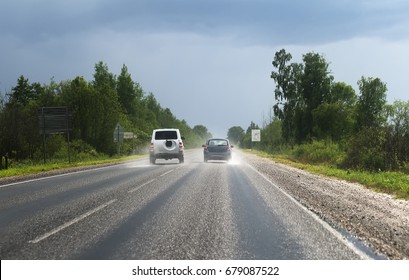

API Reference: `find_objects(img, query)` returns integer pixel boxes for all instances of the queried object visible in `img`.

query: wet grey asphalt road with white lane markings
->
[0,150,369,260]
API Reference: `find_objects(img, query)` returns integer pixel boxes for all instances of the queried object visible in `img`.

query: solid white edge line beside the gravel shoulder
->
[247,164,373,260]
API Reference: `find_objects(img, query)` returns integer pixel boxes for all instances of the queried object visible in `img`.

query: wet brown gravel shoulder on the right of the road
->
[243,153,409,259]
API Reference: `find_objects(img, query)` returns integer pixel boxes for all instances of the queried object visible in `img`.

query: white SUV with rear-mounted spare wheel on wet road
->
[149,128,185,164]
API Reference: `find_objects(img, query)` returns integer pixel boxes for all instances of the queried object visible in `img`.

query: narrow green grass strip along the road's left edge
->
[0,155,143,178]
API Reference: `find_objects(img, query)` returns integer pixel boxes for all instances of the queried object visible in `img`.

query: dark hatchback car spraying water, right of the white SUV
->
[202,138,233,162]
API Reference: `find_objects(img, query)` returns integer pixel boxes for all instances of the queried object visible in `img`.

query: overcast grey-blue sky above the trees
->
[0,0,409,137]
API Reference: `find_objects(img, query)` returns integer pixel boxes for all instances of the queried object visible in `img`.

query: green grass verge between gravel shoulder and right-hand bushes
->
[245,150,409,200]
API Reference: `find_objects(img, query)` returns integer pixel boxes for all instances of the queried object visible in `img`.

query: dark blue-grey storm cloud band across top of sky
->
[0,0,409,44]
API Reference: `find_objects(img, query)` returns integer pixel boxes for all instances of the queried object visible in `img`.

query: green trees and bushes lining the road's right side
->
[228,49,409,172]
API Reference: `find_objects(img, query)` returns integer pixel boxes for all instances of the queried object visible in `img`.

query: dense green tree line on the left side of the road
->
[0,61,210,161]
